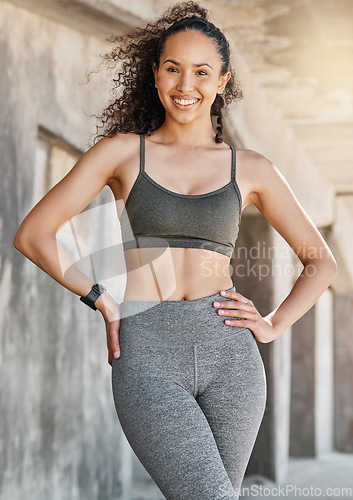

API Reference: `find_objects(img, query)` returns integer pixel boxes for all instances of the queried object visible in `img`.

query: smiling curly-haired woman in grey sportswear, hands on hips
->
[14,2,336,500]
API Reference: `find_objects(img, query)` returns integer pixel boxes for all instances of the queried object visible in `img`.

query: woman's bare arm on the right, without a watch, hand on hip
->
[213,153,337,343]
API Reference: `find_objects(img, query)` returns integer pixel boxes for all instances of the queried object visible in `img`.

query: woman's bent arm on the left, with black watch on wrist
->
[13,134,124,364]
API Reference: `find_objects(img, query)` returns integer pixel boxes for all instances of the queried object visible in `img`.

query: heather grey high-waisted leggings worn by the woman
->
[112,286,267,500]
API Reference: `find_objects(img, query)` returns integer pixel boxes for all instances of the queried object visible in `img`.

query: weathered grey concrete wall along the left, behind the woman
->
[0,2,126,500]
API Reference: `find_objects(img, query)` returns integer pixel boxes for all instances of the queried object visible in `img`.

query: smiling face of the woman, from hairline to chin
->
[153,30,231,123]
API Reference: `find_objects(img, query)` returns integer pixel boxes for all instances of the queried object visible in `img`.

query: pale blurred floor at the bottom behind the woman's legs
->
[131,452,353,500]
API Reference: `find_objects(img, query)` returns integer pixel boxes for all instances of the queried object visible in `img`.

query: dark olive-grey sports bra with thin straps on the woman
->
[120,134,242,257]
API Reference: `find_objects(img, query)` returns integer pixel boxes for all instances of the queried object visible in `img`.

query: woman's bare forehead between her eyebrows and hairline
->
[163,29,219,60]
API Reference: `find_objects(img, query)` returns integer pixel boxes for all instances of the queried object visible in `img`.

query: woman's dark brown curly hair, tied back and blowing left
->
[94,1,243,142]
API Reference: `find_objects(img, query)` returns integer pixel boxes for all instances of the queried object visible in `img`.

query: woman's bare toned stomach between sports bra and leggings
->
[123,247,233,301]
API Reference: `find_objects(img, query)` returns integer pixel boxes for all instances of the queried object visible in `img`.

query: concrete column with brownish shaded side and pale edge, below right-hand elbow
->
[290,289,333,457]
